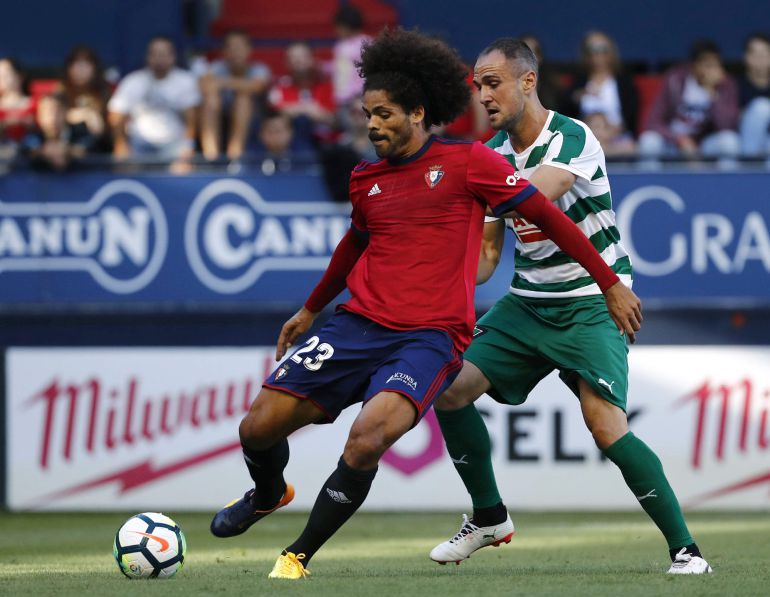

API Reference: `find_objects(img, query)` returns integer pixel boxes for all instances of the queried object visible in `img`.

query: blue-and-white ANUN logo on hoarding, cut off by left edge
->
[0,179,168,294]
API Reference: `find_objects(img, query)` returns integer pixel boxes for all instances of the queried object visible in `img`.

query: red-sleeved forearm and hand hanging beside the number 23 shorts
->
[275,228,369,361]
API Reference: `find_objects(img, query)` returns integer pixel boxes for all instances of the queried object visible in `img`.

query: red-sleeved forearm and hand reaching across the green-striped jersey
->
[504,191,642,343]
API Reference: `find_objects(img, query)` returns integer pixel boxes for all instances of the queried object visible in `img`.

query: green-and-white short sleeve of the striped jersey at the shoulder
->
[541,122,604,181]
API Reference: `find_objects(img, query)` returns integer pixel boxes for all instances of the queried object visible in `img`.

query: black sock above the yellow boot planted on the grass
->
[286,458,377,564]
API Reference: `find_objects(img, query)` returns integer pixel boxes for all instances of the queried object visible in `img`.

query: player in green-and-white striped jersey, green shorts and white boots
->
[430,38,711,574]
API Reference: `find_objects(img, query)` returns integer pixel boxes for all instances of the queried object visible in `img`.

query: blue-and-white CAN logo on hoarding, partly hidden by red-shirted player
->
[184,178,349,294]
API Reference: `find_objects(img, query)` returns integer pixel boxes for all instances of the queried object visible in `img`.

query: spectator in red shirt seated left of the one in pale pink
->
[268,42,335,149]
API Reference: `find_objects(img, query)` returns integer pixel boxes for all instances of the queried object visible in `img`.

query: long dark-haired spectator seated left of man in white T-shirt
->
[55,46,110,151]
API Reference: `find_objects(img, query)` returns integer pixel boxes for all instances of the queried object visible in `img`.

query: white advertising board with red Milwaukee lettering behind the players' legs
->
[6,346,770,510]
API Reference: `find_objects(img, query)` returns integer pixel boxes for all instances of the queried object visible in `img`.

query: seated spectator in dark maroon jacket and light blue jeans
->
[639,40,740,160]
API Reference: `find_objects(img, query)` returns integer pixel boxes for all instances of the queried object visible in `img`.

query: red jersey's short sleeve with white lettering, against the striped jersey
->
[467,143,537,216]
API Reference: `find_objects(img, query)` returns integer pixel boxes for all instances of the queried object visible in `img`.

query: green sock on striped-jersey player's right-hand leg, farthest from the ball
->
[604,431,694,549]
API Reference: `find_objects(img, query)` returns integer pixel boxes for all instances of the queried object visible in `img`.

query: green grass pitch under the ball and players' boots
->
[0,512,770,597]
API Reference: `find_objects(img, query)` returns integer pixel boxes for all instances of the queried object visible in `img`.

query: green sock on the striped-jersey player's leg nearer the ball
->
[436,404,502,508]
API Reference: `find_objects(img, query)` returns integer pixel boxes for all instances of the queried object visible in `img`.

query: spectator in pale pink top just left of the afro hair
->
[332,4,371,120]
